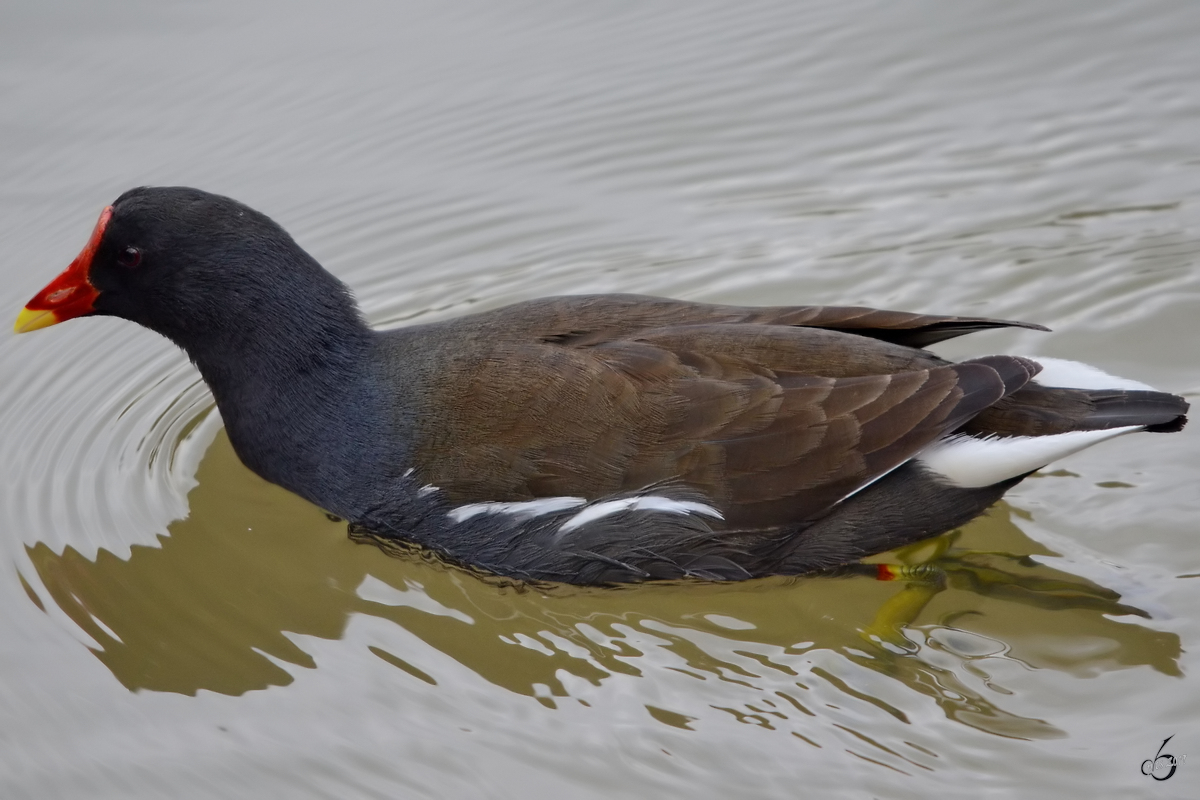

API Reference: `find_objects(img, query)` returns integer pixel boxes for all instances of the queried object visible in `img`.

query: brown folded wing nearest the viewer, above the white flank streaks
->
[418,323,1027,529]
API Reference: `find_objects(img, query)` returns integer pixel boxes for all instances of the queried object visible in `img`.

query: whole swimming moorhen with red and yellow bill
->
[16,187,1188,584]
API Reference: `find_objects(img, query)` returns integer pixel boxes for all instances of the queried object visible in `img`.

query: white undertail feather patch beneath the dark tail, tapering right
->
[917,425,1142,489]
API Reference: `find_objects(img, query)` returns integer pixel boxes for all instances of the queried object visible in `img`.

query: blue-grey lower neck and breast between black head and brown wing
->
[175,273,409,519]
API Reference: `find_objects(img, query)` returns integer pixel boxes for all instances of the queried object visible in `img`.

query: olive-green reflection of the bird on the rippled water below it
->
[29,434,1180,738]
